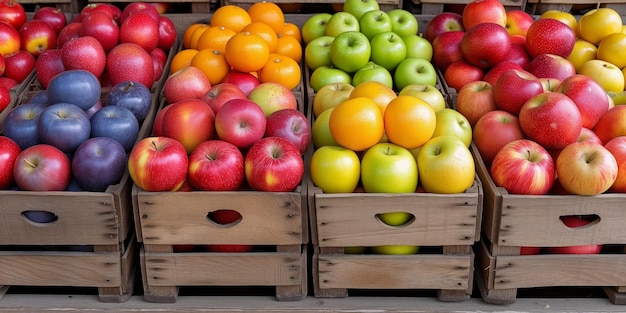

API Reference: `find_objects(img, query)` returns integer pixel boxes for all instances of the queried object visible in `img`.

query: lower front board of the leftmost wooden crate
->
[0,251,122,287]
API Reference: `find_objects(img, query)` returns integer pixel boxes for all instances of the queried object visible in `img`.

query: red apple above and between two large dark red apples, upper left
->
[79,12,120,52]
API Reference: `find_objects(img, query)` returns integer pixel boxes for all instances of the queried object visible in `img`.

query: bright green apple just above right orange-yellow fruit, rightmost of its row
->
[393,58,437,90]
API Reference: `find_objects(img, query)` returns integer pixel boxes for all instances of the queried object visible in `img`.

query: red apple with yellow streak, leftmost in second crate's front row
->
[128,137,189,191]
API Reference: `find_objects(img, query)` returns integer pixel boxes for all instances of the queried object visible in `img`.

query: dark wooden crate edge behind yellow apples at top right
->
[526,0,626,15]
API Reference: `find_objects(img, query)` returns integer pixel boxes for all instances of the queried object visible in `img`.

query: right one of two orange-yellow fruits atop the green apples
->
[383,96,437,149]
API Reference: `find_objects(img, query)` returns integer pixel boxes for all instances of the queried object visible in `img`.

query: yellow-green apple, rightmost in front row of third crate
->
[417,135,476,194]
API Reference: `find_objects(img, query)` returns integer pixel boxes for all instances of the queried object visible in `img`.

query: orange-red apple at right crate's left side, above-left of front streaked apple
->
[472,110,525,166]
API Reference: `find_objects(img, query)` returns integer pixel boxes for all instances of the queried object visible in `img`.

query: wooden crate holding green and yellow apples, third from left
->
[309,169,482,301]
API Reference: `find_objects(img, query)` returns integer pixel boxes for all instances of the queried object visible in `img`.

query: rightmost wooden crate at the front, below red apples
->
[473,143,626,304]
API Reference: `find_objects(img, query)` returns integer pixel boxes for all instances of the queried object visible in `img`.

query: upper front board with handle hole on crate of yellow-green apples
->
[314,188,480,247]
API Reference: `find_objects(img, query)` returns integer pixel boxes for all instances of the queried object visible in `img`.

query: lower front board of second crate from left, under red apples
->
[142,252,306,287]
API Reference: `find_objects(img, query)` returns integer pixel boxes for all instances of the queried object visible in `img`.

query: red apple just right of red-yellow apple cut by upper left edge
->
[19,20,57,57]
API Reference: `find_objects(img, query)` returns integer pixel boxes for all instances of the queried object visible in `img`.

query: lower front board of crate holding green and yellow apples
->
[315,254,474,290]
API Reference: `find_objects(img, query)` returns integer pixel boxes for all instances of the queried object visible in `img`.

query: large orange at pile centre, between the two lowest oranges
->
[224,32,270,72]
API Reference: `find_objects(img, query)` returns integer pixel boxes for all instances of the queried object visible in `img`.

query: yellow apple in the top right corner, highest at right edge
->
[578,8,623,45]
